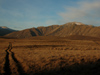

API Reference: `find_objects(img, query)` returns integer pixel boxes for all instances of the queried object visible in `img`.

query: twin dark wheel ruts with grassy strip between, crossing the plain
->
[4,43,25,75]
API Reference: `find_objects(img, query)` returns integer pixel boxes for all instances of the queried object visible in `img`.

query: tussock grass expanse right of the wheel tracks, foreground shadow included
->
[12,40,100,75]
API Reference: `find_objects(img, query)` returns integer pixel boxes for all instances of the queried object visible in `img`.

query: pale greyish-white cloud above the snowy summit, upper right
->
[58,0,100,25]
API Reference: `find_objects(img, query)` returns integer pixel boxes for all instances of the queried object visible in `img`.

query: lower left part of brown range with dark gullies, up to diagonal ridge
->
[5,25,58,38]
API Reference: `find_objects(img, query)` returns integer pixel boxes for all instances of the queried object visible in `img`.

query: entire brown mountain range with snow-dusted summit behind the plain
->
[5,22,100,38]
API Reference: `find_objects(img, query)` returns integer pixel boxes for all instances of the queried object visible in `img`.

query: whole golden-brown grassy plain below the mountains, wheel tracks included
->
[0,36,100,75]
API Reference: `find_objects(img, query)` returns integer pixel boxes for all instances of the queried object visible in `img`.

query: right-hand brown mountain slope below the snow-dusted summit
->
[48,24,100,37]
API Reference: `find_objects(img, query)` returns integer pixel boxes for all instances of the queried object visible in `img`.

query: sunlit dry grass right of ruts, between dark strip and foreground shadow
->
[13,49,100,74]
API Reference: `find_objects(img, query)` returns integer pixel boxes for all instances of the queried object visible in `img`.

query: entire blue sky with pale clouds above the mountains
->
[0,0,100,30]
